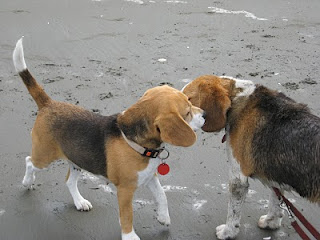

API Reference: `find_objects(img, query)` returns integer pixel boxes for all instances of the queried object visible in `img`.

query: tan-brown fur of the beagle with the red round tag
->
[20,68,199,233]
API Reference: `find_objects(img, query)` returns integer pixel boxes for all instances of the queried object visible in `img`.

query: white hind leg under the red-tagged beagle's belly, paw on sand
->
[66,162,92,211]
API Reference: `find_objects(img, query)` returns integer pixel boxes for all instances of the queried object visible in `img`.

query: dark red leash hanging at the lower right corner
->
[273,187,320,240]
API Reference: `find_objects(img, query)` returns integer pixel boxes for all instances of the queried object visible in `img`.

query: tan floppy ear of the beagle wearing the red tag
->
[155,113,197,147]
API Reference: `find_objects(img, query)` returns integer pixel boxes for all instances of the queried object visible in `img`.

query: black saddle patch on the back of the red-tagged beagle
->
[52,111,121,176]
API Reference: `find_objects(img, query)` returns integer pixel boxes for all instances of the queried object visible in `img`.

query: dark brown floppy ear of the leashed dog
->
[199,83,231,132]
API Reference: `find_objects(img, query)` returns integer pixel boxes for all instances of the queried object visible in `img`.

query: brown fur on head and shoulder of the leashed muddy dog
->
[183,75,320,201]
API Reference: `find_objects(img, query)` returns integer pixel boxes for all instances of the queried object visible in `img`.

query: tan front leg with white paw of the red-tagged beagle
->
[117,186,140,240]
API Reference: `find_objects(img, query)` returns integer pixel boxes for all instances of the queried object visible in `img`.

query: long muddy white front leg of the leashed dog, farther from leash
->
[216,145,249,239]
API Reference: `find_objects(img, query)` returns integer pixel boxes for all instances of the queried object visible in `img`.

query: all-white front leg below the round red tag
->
[148,175,170,226]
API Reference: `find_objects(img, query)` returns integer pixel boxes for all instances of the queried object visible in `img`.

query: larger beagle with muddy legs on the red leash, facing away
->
[182,75,320,239]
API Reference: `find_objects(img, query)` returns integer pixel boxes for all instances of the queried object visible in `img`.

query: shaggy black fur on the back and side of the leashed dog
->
[250,86,320,198]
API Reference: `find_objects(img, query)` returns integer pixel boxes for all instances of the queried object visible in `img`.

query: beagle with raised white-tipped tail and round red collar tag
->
[13,39,205,240]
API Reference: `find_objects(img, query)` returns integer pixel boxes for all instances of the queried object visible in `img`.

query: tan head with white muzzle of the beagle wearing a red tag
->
[118,85,205,147]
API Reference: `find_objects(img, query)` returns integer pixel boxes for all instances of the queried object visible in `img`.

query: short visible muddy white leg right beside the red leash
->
[258,189,284,229]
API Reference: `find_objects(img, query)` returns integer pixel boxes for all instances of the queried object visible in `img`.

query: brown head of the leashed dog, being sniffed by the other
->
[182,75,232,132]
